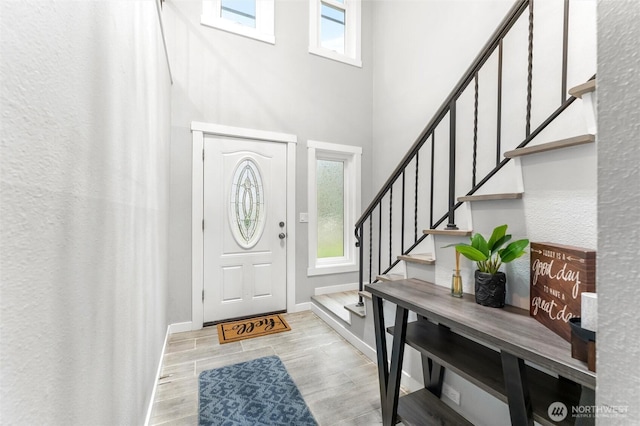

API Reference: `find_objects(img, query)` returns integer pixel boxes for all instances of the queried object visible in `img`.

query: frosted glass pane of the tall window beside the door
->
[316,160,344,259]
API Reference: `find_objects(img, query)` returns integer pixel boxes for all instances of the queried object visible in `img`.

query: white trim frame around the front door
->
[191,121,298,330]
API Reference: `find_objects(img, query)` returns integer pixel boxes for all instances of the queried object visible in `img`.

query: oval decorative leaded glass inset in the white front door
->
[229,158,265,248]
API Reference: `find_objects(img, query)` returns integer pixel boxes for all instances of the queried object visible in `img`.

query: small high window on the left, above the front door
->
[200,0,276,44]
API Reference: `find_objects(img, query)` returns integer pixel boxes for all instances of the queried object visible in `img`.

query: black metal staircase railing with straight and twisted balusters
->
[355,0,592,303]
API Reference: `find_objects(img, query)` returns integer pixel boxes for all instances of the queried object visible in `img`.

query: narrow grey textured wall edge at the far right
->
[596,0,640,425]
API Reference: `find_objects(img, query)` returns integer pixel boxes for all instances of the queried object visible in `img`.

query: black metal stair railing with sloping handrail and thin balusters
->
[355,0,595,304]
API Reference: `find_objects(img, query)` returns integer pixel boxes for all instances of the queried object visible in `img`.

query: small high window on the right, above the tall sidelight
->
[309,0,362,67]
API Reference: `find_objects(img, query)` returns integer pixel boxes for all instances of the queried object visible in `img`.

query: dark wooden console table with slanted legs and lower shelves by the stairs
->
[366,279,596,426]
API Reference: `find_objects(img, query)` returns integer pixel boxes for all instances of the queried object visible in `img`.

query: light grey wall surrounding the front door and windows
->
[165,0,372,322]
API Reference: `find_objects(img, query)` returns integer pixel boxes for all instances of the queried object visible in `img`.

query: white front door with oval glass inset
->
[203,136,287,323]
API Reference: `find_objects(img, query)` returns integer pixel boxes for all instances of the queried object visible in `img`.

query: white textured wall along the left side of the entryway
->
[0,1,170,425]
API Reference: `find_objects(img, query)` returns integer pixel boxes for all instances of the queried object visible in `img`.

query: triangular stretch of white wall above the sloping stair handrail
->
[373,0,513,188]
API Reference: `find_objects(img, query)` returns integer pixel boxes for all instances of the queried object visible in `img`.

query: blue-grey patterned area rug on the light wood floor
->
[198,356,317,426]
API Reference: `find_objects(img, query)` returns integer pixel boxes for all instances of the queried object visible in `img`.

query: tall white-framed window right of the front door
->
[307,141,362,275]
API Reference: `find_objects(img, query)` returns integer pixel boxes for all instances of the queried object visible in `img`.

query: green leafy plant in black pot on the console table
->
[453,225,529,308]
